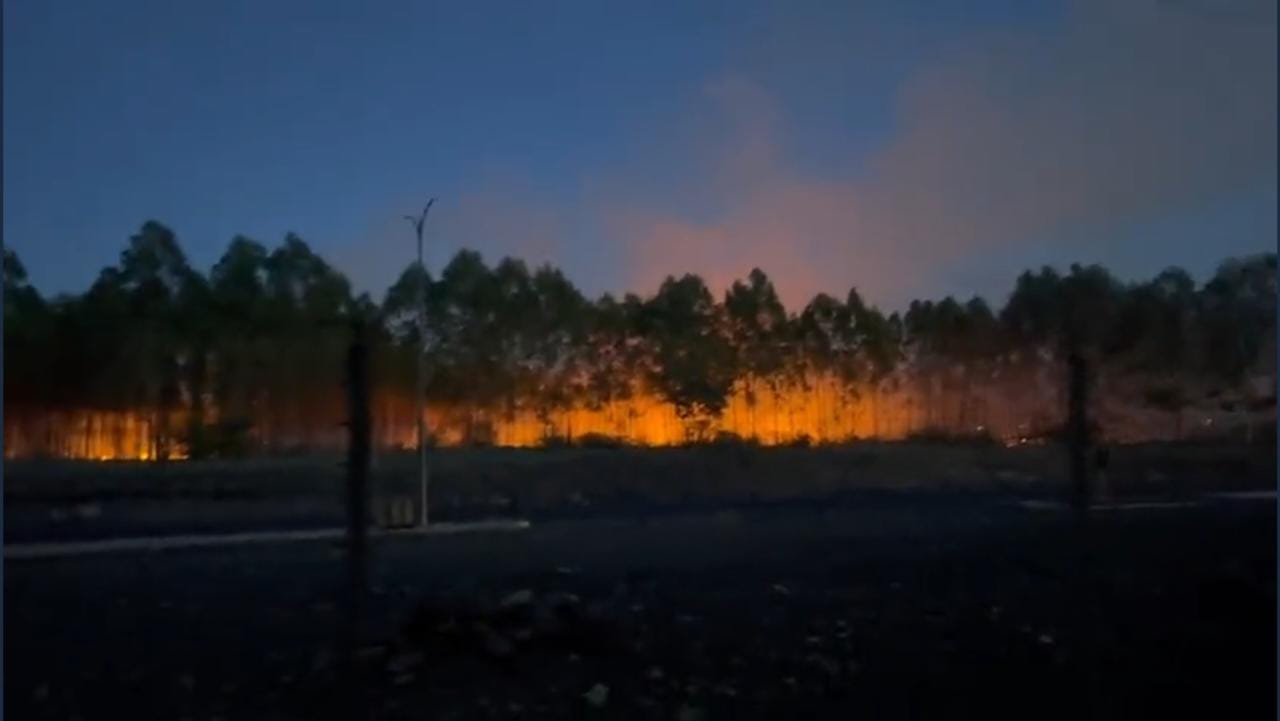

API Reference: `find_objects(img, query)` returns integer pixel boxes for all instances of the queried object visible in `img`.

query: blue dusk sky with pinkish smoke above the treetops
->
[4,0,1276,309]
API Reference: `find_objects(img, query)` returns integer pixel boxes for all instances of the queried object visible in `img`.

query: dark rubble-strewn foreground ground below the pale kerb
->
[4,490,1276,721]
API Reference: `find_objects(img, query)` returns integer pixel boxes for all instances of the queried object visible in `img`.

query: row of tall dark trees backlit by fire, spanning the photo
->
[4,222,1276,458]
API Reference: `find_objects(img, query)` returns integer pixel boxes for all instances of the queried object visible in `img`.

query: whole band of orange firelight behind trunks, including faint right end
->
[4,371,1275,461]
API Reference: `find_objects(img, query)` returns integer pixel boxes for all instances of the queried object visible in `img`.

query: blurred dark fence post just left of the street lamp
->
[343,320,371,703]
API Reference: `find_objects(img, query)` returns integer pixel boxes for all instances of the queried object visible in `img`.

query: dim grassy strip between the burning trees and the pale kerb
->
[4,443,1276,543]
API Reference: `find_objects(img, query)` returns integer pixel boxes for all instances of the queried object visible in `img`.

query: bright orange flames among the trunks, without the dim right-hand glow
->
[5,371,977,461]
